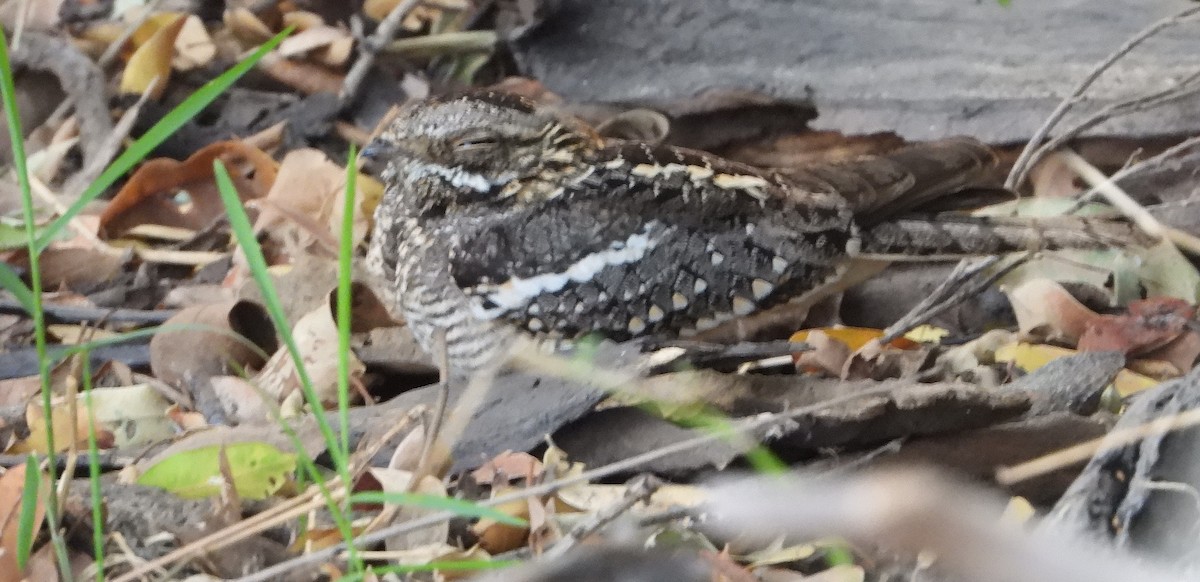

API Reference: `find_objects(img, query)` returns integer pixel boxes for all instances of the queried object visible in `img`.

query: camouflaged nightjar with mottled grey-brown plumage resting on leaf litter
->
[362,92,1137,374]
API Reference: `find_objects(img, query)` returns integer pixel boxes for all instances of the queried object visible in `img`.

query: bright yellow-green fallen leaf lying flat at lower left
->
[138,443,296,499]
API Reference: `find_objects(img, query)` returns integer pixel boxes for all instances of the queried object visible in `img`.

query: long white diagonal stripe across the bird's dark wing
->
[472,221,660,319]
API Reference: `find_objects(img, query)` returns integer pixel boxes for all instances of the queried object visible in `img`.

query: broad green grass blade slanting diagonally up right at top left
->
[37,26,293,252]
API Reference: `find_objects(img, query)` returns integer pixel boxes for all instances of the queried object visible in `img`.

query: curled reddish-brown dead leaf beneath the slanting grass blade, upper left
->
[100,140,276,236]
